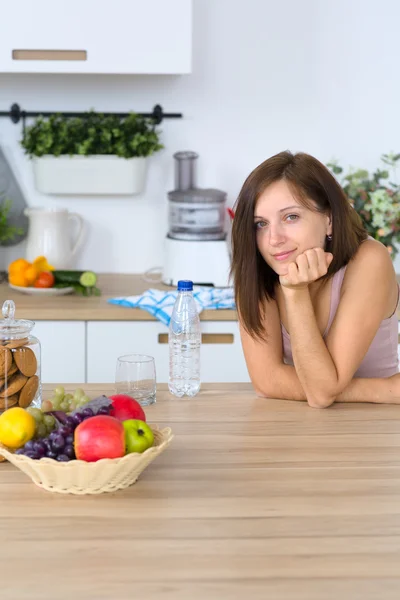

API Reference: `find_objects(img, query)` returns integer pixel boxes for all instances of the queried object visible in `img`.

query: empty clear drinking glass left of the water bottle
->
[115,354,156,406]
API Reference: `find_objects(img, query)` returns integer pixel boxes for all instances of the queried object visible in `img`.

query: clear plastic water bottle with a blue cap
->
[168,280,201,397]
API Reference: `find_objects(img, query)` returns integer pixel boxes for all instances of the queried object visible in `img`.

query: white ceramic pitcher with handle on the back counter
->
[24,208,84,269]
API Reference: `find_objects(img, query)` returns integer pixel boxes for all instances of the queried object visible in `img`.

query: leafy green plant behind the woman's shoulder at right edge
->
[327,153,400,259]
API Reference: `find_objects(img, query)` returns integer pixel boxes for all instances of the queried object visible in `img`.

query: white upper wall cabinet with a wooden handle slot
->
[0,0,192,74]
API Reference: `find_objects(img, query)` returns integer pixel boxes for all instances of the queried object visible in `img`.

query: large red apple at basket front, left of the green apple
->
[74,415,125,462]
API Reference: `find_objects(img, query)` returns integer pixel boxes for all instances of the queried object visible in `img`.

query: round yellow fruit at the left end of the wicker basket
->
[0,406,35,450]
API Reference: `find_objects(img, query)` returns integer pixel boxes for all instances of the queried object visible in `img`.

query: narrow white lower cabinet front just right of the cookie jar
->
[32,321,86,384]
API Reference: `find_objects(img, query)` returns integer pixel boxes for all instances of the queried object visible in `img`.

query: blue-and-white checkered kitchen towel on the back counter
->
[108,286,235,325]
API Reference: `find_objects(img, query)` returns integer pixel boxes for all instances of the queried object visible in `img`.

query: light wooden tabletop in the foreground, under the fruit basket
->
[0,384,400,600]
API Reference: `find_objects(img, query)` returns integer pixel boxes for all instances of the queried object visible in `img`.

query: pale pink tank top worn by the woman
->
[281,265,400,377]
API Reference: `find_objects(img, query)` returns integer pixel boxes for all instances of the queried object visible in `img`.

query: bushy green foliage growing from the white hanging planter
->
[21,111,163,158]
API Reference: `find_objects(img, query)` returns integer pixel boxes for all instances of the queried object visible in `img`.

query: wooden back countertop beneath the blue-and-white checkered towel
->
[0,273,237,321]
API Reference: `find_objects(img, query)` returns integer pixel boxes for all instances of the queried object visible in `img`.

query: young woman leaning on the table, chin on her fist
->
[232,152,400,408]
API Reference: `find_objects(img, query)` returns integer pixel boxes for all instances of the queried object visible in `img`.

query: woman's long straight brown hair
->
[231,151,368,339]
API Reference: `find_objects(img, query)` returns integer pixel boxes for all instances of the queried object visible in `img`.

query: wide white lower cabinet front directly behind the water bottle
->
[87,321,250,383]
